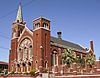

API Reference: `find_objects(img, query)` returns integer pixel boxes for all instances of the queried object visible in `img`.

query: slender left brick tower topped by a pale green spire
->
[9,5,25,72]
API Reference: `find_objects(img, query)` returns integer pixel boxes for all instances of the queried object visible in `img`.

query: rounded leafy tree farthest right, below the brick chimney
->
[86,53,96,66]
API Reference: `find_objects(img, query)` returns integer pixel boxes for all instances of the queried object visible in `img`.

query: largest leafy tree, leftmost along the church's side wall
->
[62,49,74,65]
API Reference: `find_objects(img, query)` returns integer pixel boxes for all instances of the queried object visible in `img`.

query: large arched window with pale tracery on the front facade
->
[18,38,33,61]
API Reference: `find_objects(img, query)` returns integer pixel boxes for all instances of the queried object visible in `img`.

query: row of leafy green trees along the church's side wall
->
[62,49,96,67]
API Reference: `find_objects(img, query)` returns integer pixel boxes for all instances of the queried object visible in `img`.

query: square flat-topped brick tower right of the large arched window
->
[33,17,51,69]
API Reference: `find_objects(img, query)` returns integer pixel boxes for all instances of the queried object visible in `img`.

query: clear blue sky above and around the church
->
[0,0,100,62]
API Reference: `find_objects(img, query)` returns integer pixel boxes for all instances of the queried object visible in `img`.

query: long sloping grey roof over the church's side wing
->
[51,36,84,51]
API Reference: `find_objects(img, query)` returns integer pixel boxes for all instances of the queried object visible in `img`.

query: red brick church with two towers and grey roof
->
[9,6,94,72]
